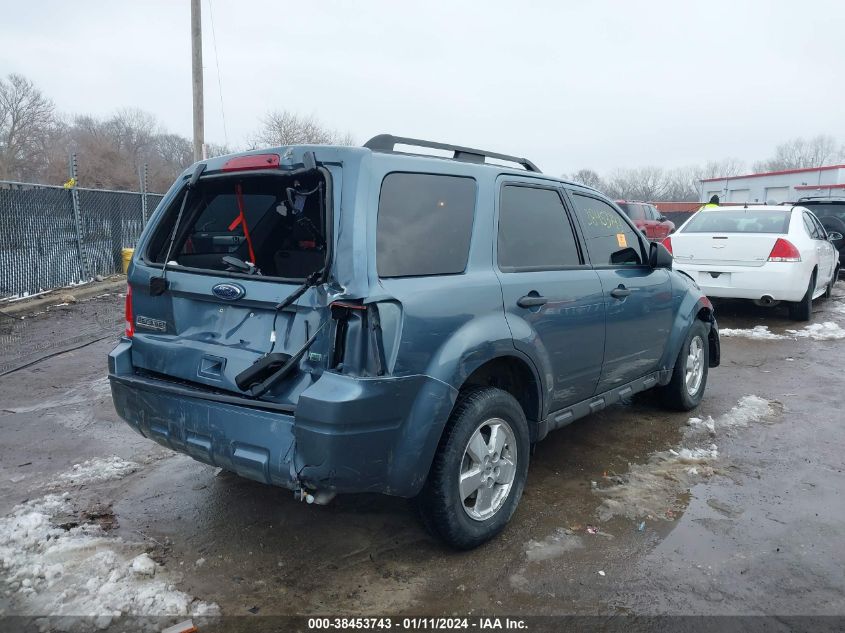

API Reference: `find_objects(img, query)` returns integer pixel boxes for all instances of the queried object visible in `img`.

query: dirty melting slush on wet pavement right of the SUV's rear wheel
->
[595,395,781,521]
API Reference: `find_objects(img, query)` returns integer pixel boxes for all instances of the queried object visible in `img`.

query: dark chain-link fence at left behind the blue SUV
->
[0,181,162,299]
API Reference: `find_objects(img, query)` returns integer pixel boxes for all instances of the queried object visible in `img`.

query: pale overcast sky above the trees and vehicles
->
[0,0,845,175]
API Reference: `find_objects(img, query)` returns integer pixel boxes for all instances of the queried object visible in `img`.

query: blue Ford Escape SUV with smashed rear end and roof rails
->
[109,135,719,549]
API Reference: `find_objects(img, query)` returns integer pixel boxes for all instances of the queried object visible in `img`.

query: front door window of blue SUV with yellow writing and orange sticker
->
[572,193,643,266]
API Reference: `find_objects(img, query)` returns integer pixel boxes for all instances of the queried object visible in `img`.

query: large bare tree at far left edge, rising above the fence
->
[0,74,56,180]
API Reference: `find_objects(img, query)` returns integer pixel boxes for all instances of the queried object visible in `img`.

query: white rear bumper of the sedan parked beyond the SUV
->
[673,259,810,301]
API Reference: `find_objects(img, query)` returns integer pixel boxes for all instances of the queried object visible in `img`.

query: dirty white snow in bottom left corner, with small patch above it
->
[0,457,220,631]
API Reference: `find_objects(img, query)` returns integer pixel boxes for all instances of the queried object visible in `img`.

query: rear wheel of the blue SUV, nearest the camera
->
[414,387,530,550]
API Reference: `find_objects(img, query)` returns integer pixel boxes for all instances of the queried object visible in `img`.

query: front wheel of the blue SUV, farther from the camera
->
[660,319,710,411]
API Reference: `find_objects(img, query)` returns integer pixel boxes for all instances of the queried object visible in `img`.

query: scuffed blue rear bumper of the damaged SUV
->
[109,340,457,497]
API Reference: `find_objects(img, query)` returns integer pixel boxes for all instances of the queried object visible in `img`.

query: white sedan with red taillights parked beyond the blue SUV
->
[663,205,842,321]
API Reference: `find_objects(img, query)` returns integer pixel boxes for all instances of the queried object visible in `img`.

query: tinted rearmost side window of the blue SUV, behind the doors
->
[376,173,476,277]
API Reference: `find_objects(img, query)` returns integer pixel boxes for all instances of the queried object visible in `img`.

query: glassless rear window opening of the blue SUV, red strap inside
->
[147,175,329,279]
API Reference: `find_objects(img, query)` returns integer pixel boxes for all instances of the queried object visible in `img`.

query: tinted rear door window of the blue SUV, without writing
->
[498,185,581,272]
